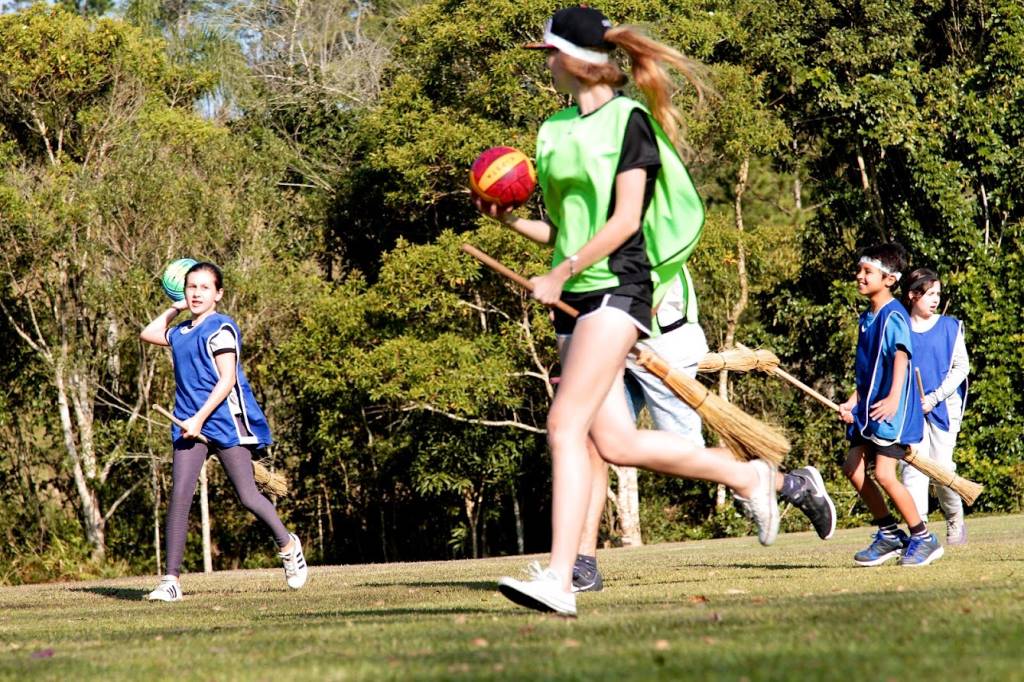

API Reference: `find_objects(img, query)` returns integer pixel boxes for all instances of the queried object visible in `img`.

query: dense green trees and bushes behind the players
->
[0,0,1024,582]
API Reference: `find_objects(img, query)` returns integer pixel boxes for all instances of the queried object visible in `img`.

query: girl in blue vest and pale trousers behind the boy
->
[903,267,971,545]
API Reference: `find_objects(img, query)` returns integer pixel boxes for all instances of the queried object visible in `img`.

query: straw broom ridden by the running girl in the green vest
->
[462,244,790,465]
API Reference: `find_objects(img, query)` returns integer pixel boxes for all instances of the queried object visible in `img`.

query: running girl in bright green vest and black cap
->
[477,7,778,615]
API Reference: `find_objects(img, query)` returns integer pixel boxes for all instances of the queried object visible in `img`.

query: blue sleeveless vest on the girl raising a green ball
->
[167,312,272,447]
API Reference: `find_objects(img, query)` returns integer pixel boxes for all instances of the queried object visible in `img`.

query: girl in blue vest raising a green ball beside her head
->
[139,262,307,601]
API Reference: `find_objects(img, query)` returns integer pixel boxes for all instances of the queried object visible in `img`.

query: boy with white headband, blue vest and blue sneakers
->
[840,244,943,566]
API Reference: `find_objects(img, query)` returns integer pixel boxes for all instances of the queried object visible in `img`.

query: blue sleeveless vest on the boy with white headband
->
[847,299,925,445]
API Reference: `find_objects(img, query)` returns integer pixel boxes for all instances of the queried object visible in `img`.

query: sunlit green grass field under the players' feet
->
[0,516,1024,682]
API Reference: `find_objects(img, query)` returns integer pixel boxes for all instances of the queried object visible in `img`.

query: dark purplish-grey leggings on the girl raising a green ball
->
[164,440,291,576]
